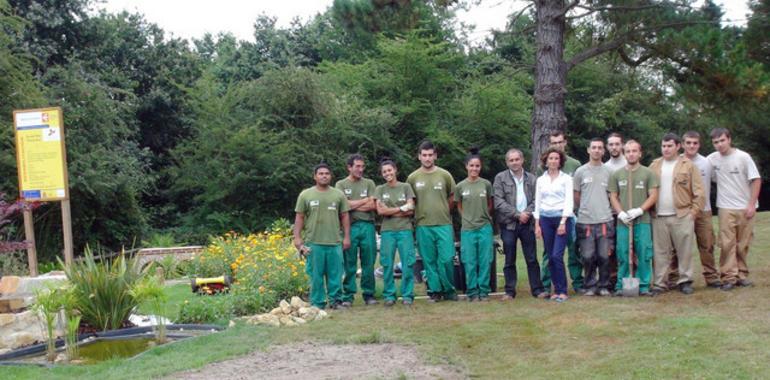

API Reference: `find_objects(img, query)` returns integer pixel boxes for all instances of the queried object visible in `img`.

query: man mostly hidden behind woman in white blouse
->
[537,131,585,294]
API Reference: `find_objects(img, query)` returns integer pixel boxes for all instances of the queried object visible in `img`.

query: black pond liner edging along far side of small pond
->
[0,324,223,365]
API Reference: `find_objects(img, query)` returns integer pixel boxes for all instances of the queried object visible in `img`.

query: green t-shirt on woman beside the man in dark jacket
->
[455,178,493,230]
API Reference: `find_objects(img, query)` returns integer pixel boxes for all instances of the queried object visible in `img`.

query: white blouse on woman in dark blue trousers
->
[533,171,574,219]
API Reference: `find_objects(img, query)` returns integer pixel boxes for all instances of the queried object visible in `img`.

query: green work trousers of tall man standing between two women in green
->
[416,224,457,298]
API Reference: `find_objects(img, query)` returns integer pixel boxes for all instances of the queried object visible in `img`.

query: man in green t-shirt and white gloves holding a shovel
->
[608,140,659,296]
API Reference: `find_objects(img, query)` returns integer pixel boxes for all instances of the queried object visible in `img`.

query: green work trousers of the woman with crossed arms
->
[380,230,415,301]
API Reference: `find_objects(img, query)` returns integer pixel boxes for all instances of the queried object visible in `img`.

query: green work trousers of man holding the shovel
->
[615,222,653,292]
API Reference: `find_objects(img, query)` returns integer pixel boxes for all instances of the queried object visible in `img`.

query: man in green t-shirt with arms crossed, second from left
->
[334,153,377,306]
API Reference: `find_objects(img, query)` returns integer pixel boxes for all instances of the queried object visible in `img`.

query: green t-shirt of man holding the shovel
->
[608,165,660,223]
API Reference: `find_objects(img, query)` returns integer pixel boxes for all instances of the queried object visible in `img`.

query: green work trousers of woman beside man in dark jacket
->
[460,224,494,298]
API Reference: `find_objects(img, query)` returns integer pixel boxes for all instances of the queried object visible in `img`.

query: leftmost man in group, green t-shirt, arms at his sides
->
[294,163,350,309]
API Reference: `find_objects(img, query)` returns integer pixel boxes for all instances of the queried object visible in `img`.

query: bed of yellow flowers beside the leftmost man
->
[178,227,309,323]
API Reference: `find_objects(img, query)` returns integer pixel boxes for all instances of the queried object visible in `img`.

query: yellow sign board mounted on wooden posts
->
[13,107,69,201]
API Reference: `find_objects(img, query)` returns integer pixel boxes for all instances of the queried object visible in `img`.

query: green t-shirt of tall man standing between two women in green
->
[406,167,455,226]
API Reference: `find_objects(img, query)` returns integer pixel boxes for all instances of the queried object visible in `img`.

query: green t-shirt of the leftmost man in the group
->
[294,186,349,245]
